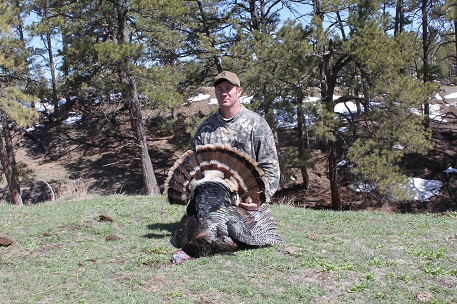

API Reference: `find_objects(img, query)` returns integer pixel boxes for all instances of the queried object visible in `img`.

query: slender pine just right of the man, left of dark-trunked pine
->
[268,22,318,190]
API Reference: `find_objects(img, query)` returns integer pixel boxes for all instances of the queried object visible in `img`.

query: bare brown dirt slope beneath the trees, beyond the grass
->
[0,86,457,213]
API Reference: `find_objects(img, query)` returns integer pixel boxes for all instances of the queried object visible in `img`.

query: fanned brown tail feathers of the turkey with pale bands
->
[164,145,268,205]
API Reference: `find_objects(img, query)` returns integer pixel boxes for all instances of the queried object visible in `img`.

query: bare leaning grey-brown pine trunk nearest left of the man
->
[129,76,160,195]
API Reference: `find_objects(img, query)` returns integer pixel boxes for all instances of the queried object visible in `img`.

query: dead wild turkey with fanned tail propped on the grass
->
[164,145,282,260]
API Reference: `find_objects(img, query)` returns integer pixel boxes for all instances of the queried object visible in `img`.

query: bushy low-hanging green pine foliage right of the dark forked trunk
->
[348,20,436,200]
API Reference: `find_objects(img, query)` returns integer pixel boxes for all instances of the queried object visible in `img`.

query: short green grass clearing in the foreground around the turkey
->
[0,196,457,304]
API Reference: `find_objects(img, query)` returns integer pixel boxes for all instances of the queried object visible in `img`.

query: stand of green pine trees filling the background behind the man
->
[0,0,457,210]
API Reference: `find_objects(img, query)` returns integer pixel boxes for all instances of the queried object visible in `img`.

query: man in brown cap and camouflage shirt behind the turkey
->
[194,71,280,210]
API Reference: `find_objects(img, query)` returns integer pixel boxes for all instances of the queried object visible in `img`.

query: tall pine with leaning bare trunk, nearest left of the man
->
[43,0,191,194]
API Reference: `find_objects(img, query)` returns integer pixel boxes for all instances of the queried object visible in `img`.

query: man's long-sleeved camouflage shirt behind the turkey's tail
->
[194,105,280,197]
